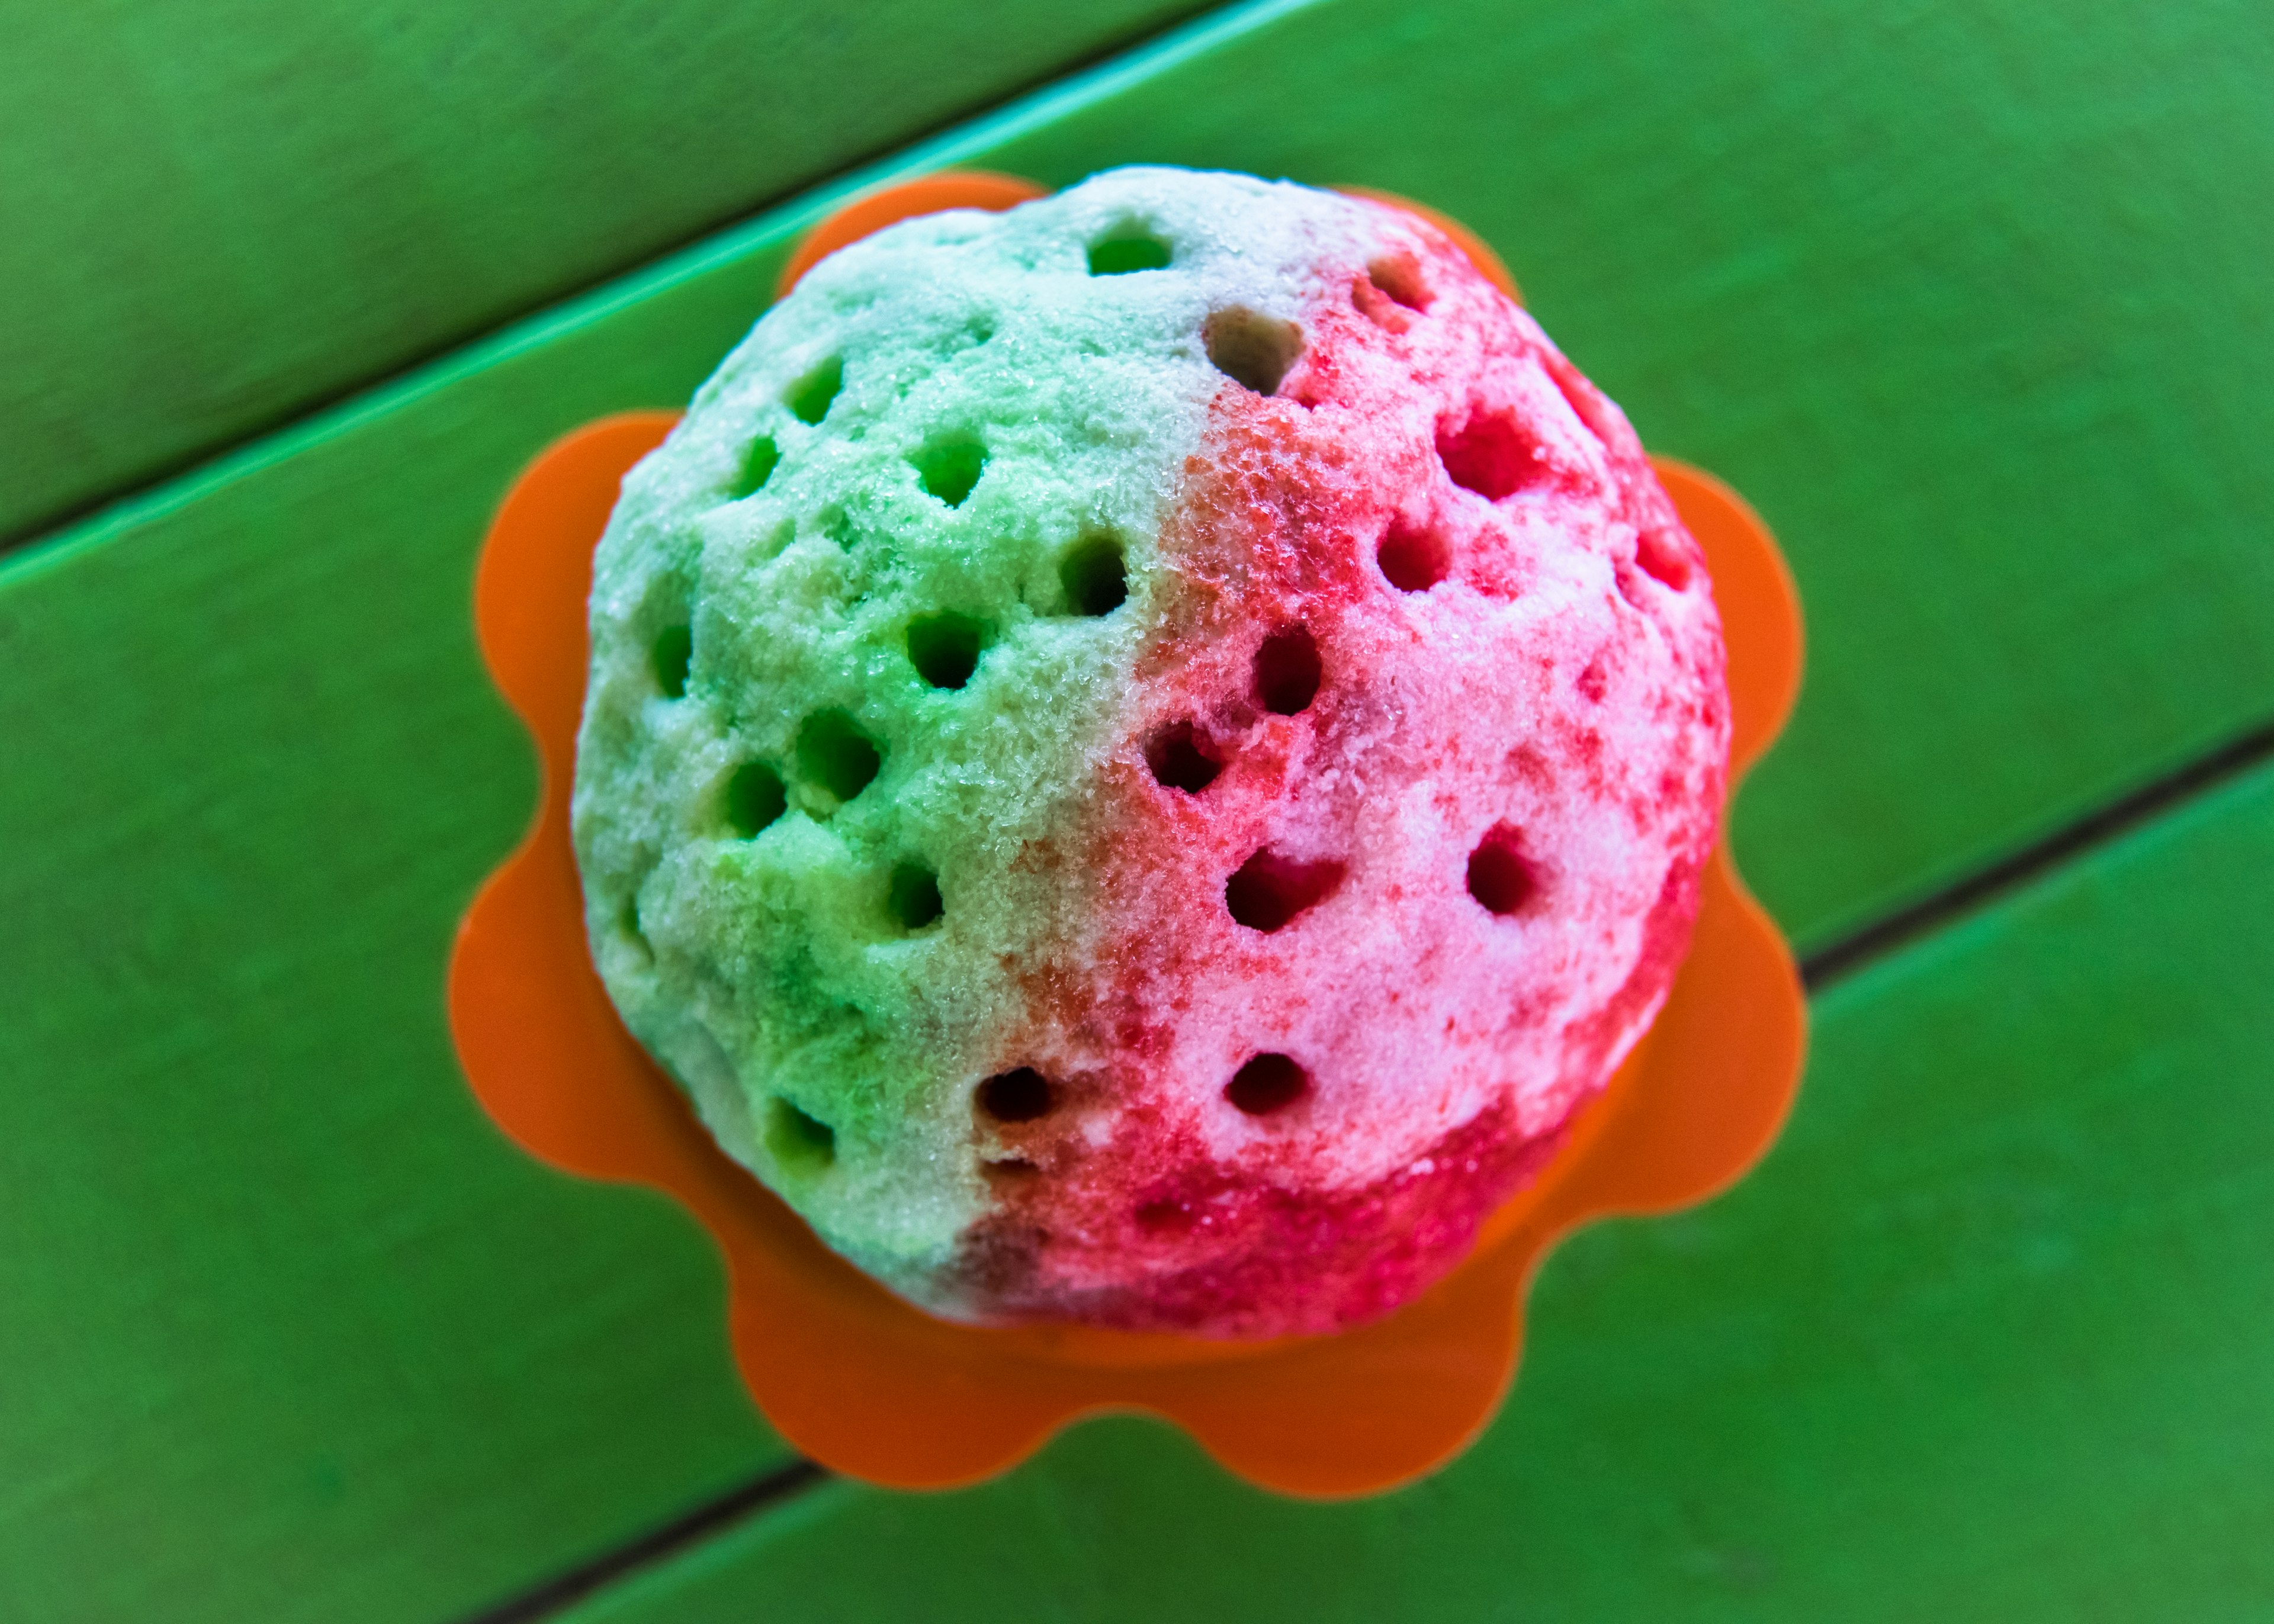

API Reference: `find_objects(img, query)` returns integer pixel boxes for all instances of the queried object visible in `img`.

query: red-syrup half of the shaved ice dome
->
[958,193,1728,1337]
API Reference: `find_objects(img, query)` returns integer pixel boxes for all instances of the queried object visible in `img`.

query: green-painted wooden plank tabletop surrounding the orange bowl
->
[0,0,2274,1624]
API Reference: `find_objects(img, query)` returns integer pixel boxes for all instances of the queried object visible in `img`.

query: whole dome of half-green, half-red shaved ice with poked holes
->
[573,168,1728,1335]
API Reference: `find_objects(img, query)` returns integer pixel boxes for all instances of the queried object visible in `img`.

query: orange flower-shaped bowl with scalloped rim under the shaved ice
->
[450,175,1806,1494]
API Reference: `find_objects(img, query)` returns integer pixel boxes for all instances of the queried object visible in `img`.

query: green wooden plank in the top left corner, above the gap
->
[0,0,1191,539]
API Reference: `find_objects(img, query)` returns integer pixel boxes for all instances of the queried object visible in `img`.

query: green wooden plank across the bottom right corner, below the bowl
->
[541,771,2274,1624]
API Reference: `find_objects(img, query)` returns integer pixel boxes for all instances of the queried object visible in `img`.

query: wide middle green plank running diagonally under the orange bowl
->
[0,0,2274,1619]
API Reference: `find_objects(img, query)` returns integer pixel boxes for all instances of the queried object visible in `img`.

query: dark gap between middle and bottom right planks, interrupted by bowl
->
[462,719,2274,1624]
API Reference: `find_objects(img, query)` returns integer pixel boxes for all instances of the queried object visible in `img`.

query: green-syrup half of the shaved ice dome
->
[573,171,1382,1310]
